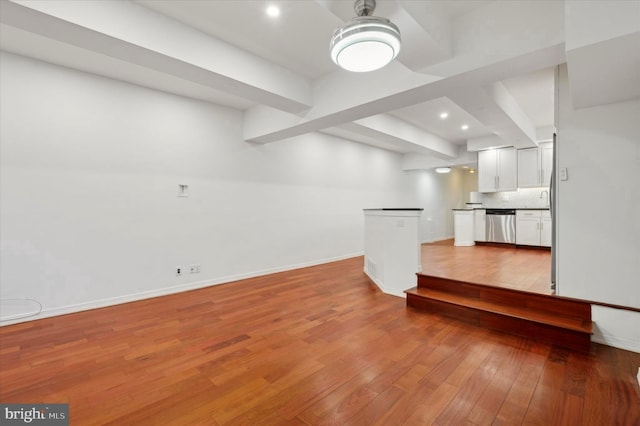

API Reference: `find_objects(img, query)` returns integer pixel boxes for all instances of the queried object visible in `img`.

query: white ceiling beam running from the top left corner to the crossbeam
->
[0,0,311,113]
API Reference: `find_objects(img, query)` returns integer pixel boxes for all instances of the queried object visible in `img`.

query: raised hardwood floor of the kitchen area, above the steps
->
[421,240,553,294]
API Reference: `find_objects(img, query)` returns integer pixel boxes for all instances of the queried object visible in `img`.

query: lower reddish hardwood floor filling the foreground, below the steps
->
[0,257,640,426]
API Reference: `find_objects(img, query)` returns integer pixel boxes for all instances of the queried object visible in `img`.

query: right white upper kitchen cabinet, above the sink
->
[518,142,553,188]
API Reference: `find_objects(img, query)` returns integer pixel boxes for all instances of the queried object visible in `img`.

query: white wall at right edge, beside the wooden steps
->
[557,65,640,352]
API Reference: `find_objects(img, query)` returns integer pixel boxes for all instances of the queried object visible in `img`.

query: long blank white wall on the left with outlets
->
[0,53,420,317]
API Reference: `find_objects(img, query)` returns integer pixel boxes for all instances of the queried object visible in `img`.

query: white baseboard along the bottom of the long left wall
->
[0,252,364,327]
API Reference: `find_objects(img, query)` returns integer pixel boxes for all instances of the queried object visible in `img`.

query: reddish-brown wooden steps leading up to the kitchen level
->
[405,274,593,351]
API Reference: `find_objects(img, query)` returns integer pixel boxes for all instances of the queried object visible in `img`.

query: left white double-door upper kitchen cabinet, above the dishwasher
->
[478,148,518,192]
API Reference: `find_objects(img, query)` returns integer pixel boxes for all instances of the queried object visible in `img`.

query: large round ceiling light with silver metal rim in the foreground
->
[330,0,400,72]
